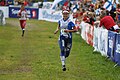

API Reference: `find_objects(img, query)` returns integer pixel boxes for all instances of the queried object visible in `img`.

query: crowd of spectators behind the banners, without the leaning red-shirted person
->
[0,0,120,29]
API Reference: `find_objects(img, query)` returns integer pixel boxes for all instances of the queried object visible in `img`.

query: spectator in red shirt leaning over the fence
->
[99,11,120,32]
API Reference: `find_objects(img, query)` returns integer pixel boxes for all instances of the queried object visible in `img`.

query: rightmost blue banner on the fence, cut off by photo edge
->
[114,34,120,65]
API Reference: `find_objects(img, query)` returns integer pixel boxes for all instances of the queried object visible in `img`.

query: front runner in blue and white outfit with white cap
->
[54,10,77,71]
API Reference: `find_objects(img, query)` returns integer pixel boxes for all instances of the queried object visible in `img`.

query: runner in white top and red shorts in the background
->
[17,4,28,37]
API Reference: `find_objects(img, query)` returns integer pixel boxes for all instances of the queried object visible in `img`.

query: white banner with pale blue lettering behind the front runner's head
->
[38,9,62,22]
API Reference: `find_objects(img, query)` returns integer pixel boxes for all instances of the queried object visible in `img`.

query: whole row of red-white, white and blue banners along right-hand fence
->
[80,22,120,66]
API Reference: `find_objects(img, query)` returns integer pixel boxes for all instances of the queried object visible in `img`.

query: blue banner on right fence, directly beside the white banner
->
[107,31,116,59]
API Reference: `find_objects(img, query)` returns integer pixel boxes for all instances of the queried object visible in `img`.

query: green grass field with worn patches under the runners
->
[0,19,120,80]
